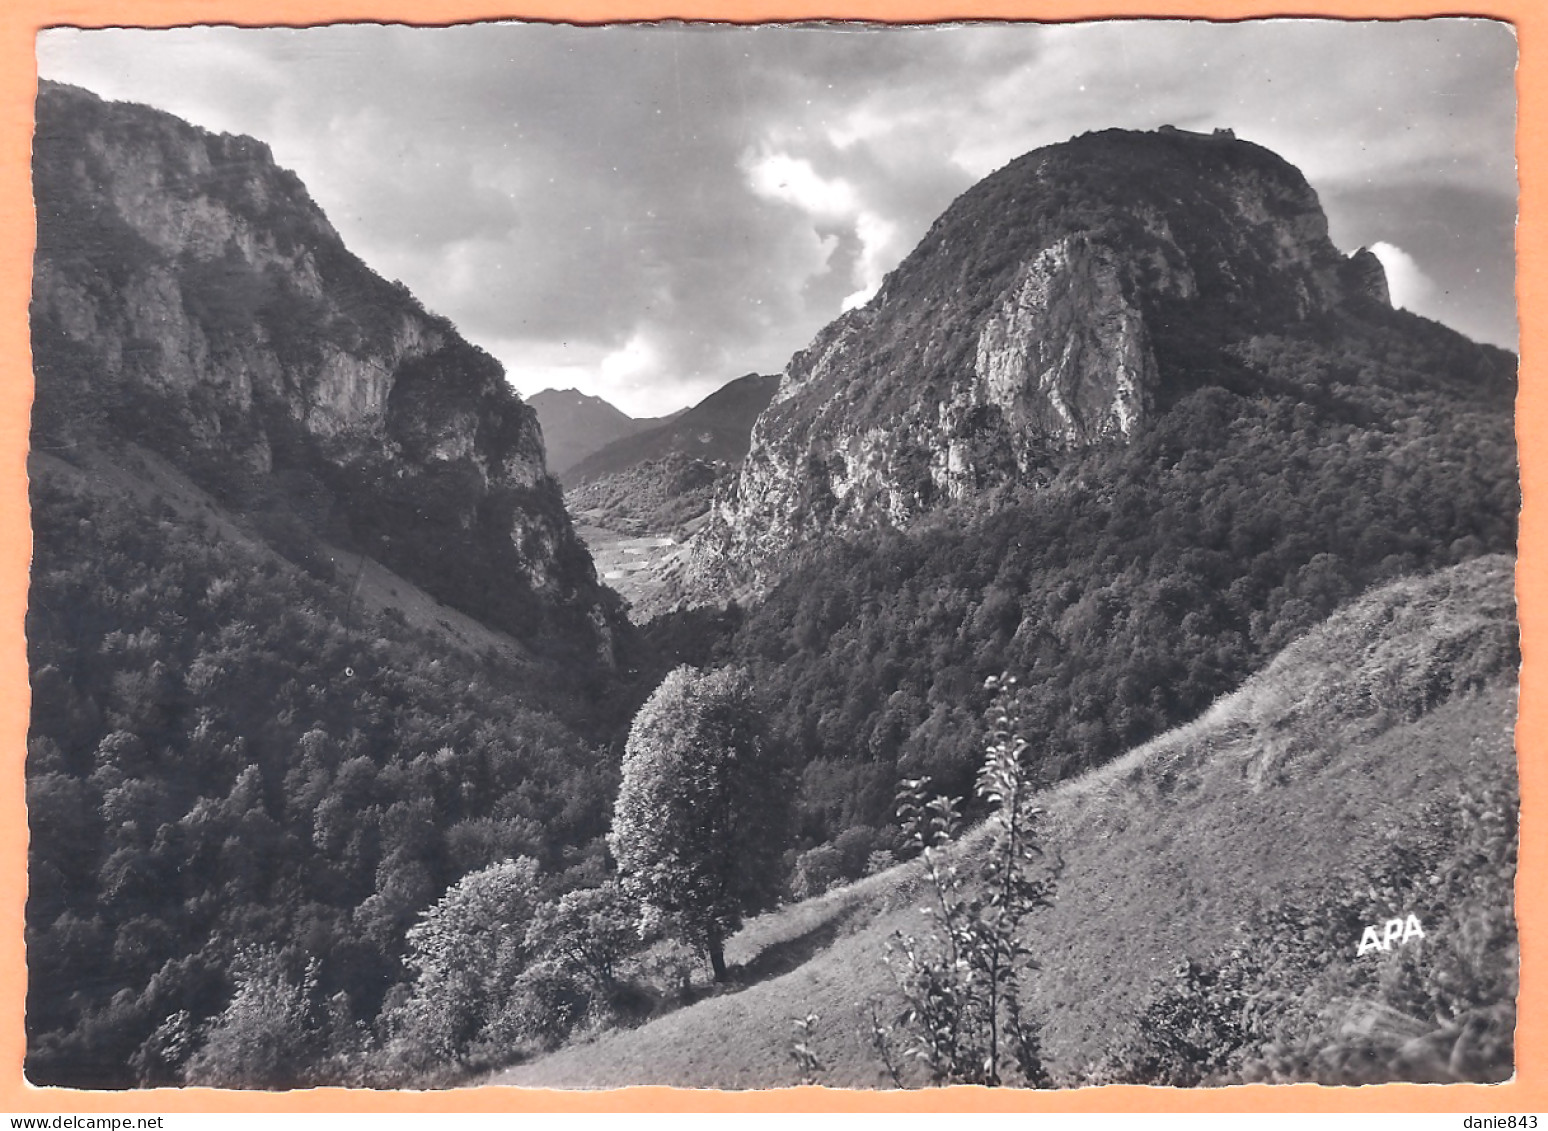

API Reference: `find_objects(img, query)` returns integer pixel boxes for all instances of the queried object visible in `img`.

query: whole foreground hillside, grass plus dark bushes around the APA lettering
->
[494,557,1519,1088]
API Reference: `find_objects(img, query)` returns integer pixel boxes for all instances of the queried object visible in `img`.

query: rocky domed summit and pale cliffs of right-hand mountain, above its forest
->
[694,128,1387,589]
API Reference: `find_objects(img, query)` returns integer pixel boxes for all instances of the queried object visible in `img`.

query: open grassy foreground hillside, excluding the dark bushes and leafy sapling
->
[495,557,1515,1088]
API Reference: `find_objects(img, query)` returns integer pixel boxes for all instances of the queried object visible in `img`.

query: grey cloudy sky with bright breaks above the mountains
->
[37,20,1515,416]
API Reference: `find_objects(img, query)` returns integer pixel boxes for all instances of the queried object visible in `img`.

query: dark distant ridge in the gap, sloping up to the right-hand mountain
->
[562,373,780,486]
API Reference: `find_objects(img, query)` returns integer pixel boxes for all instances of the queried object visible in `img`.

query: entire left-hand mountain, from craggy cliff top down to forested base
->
[26,84,649,1088]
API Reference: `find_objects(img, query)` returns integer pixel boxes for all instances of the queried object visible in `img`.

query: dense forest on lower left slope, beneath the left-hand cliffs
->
[28,454,640,1086]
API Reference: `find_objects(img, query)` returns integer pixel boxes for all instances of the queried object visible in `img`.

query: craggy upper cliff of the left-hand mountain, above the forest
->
[33,84,616,658]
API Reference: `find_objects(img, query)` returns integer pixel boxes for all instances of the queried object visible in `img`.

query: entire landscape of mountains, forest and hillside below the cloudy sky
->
[26,82,1520,1089]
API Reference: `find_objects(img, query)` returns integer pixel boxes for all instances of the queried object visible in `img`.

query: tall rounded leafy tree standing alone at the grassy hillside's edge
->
[608,667,793,981]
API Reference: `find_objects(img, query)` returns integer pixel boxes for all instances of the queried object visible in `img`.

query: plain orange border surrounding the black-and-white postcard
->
[0,0,1548,1114]
